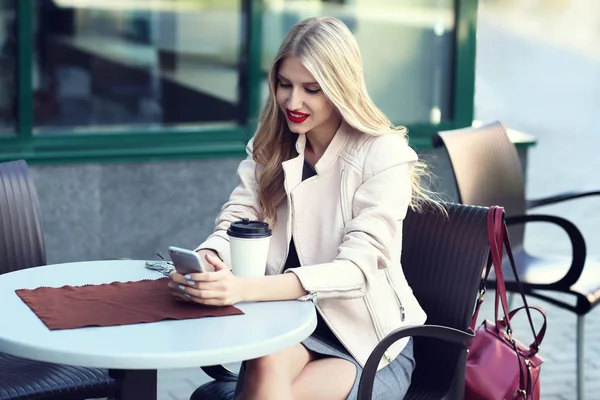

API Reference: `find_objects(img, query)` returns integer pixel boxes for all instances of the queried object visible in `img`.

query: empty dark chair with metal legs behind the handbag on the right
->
[434,122,600,399]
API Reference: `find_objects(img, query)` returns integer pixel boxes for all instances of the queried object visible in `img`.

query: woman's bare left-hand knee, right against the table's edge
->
[236,343,314,400]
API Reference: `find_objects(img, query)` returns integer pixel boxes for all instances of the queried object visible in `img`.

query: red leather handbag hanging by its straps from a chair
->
[465,207,546,400]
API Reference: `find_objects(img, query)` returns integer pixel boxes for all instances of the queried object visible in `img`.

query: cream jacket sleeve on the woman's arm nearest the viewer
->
[286,134,417,299]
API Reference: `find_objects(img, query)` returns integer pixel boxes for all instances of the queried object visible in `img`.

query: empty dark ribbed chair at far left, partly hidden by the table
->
[0,160,119,400]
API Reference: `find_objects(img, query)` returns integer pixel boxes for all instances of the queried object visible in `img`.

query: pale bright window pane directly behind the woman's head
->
[262,0,455,124]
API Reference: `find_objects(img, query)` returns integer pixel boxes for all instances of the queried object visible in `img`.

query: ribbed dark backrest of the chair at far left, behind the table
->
[0,160,46,274]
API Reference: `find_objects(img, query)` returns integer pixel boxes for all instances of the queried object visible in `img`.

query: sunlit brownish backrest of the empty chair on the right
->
[434,122,526,249]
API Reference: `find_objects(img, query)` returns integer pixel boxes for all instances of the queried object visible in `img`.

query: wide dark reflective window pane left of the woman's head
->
[34,0,243,133]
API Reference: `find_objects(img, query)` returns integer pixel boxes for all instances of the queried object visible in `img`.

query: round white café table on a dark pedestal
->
[0,260,317,399]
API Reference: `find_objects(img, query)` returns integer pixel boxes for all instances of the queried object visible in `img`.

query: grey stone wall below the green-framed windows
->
[31,145,525,264]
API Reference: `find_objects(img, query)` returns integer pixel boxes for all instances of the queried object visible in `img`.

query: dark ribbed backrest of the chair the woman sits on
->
[402,204,489,398]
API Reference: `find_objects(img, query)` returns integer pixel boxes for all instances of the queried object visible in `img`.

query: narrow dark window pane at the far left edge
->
[0,0,17,135]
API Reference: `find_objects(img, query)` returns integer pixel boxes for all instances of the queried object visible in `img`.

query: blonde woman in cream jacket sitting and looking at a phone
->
[169,18,426,400]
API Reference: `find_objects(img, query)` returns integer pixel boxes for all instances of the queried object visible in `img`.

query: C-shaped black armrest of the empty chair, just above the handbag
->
[506,214,587,289]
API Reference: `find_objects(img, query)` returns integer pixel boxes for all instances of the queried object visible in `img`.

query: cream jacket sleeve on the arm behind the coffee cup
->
[196,138,262,268]
